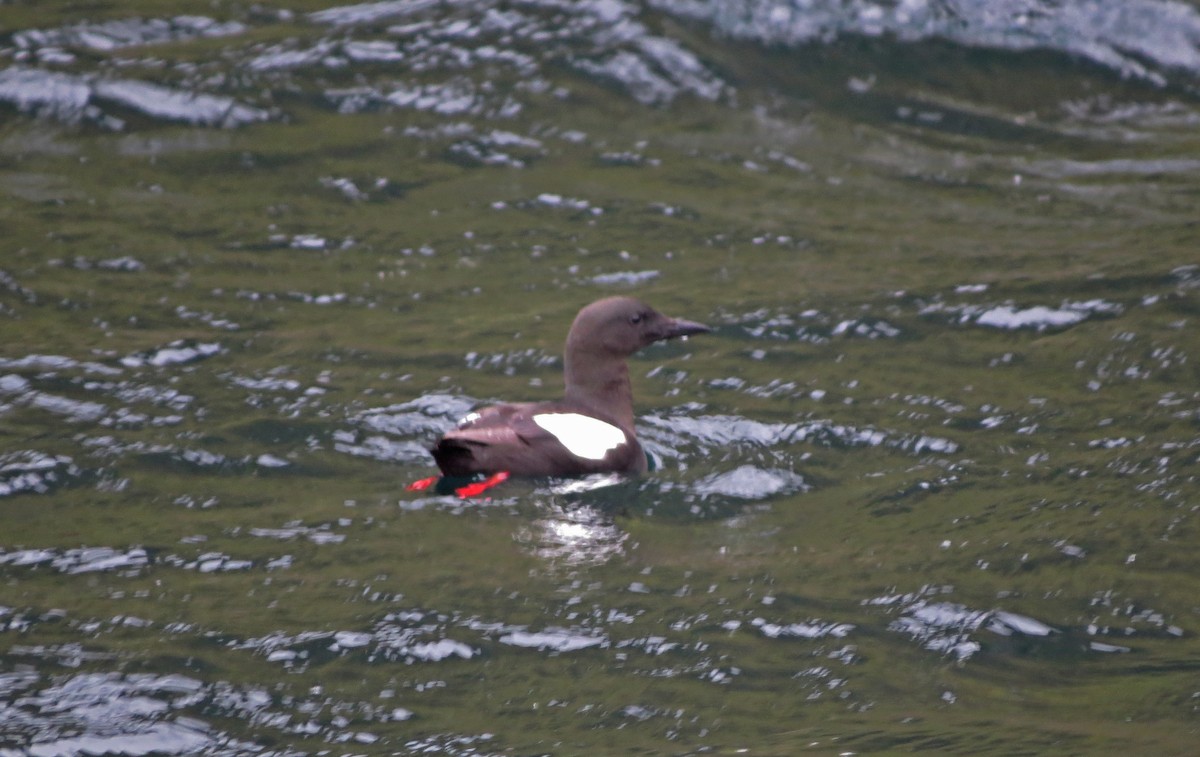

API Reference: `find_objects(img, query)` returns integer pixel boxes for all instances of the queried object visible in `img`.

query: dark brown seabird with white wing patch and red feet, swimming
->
[409,298,710,495]
